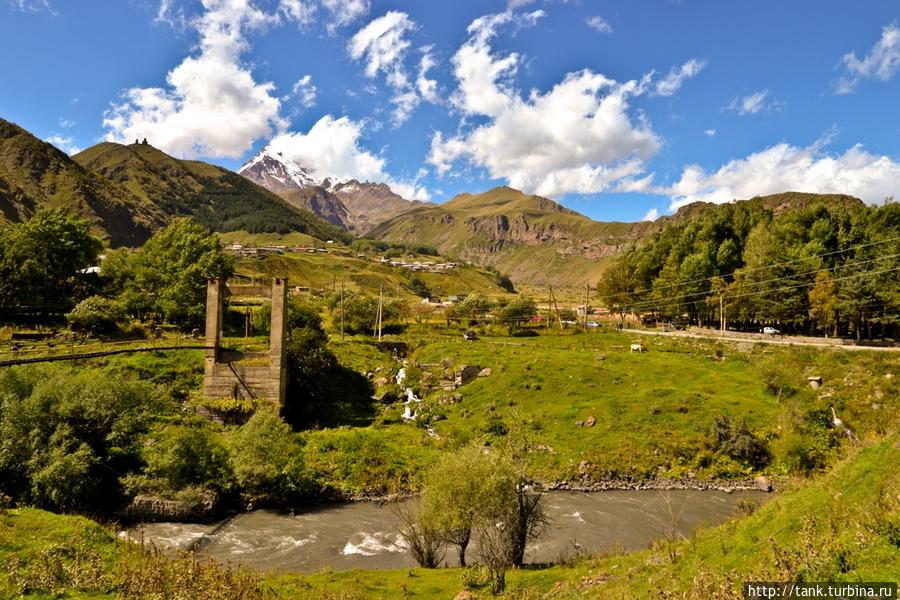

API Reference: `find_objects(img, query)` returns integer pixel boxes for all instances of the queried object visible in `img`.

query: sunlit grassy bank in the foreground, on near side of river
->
[0,436,900,600]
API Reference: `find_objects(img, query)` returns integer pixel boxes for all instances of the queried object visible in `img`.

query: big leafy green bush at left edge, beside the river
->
[0,365,159,513]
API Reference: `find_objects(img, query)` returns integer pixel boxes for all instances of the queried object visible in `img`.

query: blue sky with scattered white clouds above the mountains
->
[0,0,900,221]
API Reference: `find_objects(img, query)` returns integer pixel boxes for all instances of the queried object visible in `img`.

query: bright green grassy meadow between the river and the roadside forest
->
[404,333,900,479]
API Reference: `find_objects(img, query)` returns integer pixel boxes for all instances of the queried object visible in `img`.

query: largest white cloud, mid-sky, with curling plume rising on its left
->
[428,11,659,196]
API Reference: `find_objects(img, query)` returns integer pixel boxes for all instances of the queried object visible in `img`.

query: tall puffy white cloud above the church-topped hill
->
[103,0,286,158]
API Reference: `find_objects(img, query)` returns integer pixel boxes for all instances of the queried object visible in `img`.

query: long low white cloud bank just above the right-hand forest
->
[653,139,900,210]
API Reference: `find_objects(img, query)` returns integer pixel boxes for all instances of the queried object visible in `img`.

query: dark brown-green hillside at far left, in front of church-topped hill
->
[0,119,165,246]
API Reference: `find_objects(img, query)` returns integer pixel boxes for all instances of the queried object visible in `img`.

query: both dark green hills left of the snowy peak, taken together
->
[0,119,349,246]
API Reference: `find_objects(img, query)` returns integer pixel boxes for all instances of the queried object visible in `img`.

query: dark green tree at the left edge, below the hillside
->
[0,208,103,313]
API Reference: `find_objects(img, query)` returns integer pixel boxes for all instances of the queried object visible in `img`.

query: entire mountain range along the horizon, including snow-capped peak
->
[0,119,862,285]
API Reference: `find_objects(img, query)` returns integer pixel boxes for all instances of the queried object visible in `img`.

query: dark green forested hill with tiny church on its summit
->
[74,142,346,239]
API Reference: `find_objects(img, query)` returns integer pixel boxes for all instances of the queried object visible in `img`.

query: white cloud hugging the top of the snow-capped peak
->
[267,115,429,200]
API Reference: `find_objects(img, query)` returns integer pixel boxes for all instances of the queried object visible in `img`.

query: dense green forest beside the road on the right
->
[599,194,900,339]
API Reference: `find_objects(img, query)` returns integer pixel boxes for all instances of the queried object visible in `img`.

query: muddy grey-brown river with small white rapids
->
[127,490,766,573]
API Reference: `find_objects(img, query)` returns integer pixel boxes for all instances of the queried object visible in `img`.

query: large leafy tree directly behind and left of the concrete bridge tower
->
[122,218,234,326]
